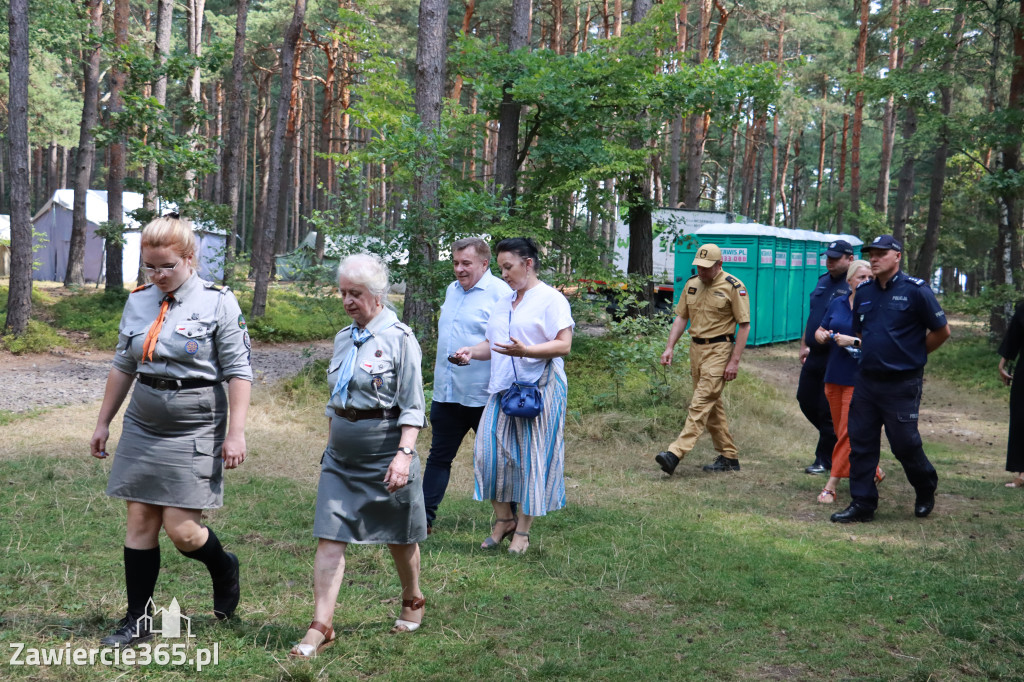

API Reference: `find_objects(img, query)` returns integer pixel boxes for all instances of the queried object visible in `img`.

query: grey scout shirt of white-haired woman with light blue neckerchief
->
[324,308,426,428]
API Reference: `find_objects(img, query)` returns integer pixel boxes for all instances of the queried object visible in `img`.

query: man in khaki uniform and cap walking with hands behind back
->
[654,244,751,476]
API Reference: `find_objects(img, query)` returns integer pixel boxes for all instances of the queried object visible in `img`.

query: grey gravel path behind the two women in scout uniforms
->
[0,341,332,412]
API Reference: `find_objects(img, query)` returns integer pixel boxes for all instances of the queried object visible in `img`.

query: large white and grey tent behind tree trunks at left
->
[32,189,226,282]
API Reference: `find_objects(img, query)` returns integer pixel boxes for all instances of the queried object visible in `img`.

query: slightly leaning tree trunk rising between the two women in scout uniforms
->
[252,0,306,317]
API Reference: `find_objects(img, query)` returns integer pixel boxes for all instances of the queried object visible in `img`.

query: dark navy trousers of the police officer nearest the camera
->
[849,374,939,511]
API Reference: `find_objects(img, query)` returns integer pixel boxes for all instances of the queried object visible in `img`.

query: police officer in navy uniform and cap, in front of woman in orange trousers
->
[831,235,949,523]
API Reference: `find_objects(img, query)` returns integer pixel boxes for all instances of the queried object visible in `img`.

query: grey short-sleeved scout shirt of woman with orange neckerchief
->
[114,272,253,381]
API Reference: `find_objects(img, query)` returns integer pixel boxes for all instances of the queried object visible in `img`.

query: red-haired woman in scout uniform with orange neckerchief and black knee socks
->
[90,216,252,646]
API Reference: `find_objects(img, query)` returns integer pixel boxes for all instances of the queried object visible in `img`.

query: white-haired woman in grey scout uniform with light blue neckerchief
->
[289,254,427,658]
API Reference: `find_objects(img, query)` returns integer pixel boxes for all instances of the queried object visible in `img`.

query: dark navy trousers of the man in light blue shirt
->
[423,401,483,525]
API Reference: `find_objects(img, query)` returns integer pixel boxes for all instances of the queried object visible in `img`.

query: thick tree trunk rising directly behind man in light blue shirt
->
[402,0,452,338]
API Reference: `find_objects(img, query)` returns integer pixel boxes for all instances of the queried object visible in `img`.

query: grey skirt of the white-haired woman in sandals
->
[313,417,427,545]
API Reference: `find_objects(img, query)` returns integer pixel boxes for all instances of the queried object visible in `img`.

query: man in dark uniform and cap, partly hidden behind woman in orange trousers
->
[797,240,853,474]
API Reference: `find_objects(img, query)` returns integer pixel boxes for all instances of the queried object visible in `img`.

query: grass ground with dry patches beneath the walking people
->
[0,321,1024,682]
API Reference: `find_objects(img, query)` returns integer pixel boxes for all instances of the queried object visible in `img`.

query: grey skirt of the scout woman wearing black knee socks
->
[106,382,227,509]
